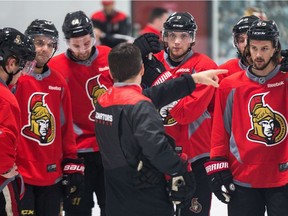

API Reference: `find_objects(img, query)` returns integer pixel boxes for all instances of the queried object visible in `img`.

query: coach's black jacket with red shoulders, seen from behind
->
[95,83,186,216]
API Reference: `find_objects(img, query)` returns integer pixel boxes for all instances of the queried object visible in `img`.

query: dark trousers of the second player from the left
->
[20,182,63,216]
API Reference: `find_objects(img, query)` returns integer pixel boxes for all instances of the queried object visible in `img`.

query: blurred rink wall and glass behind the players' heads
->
[0,0,288,64]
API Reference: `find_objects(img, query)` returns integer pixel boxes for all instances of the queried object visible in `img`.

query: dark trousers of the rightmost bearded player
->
[228,185,288,216]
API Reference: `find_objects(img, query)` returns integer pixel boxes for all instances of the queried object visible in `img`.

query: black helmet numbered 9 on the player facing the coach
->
[163,12,197,32]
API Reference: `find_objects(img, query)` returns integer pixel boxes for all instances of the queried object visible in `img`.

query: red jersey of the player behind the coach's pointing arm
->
[154,51,217,162]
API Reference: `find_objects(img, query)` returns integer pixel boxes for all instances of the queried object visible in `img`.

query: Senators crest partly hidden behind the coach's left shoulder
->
[86,75,107,121]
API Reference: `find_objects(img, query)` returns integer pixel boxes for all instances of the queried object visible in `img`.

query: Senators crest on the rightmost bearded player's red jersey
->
[246,93,287,146]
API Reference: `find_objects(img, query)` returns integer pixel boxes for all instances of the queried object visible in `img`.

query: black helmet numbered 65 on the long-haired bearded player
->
[247,19,279,44]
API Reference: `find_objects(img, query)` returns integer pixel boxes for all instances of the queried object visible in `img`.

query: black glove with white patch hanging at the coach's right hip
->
[168,153,196,208]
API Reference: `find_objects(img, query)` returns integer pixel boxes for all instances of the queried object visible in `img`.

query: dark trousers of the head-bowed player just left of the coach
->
[63,152,105,216]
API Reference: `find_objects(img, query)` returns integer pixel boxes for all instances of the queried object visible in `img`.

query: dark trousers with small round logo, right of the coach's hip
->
[181,158,212,216]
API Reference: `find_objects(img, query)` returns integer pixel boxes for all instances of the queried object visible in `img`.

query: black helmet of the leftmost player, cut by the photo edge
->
[0,27,36,69]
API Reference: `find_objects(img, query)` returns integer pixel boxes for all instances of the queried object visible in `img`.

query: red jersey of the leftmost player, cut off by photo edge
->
[0,79,21,187]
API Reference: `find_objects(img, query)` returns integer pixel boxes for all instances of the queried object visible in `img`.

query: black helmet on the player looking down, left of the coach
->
[62,11,94,39]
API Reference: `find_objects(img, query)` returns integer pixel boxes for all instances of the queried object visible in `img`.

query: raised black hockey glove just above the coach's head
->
[133,33,161,59]
